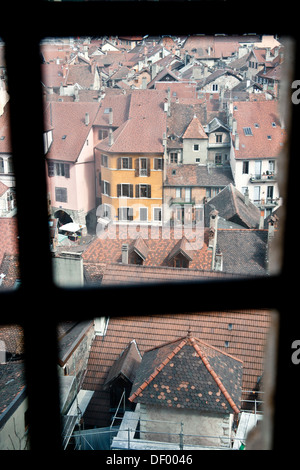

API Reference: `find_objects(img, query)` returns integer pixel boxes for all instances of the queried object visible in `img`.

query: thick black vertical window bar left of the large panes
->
[5,30,60,450]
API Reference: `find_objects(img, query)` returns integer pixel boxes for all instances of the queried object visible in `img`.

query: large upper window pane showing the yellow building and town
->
[39,34,290,286]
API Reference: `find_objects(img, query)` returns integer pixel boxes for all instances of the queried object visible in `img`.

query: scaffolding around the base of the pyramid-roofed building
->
[69,390,263,450]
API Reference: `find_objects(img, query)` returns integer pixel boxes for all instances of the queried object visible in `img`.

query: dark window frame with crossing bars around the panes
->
[0,1,300,452]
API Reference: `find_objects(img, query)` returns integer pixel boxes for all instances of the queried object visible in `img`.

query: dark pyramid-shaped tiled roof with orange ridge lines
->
[129,334,243,413]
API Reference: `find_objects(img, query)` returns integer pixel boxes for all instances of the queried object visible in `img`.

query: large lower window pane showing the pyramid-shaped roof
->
[59,310,278,451]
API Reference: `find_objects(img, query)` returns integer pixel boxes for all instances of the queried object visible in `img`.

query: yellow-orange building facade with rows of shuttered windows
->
[95,149,164,224]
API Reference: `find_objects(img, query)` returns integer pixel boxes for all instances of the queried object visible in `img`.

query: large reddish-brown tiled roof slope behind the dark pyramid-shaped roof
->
[83,310,271,427]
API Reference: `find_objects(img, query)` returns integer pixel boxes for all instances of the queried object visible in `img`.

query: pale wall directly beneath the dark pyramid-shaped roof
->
[140,404,233,447]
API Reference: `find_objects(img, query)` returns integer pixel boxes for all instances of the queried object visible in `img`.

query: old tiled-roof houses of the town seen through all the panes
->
[0,35,286,448]
